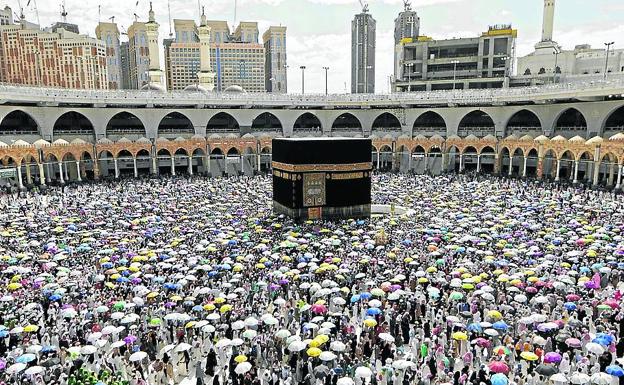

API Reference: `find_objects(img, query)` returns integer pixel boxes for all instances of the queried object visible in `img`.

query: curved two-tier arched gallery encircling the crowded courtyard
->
[0,79,624,187]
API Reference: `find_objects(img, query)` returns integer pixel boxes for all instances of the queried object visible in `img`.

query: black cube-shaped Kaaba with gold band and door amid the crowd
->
[272,138,373,220]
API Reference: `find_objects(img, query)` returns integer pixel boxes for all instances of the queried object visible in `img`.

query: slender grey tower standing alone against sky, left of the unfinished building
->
[351,6,376,94]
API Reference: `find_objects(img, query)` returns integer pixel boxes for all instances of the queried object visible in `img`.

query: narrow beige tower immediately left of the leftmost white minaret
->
[128,21,149,89]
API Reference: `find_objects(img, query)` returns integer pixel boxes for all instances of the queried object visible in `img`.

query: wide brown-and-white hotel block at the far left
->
[0,19,108,89]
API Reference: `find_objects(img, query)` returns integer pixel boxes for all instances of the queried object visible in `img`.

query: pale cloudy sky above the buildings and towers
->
[15,0,624,93]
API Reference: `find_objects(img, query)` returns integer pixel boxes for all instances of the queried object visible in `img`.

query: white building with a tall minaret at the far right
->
[514,0,624,81]
